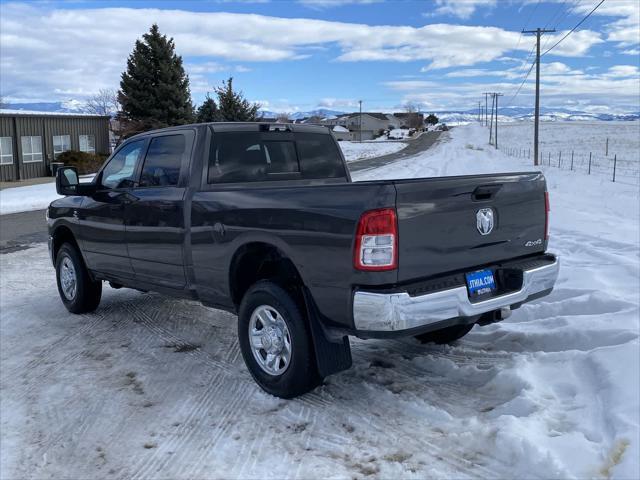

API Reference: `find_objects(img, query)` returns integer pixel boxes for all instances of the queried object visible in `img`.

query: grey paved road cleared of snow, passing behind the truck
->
[0,132,441,254]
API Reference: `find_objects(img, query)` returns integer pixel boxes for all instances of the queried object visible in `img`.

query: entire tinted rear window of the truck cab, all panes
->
[208,132,346,183]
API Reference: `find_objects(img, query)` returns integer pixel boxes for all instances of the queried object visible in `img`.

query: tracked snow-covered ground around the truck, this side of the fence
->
[0,125,640,479]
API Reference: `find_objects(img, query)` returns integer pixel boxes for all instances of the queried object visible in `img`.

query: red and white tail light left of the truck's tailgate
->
[353,208,398,271]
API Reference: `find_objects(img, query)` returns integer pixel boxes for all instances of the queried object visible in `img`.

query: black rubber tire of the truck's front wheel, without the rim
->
[56,243,102,313]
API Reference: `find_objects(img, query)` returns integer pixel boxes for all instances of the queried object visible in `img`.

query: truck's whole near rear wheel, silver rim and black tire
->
[238,280,322,398]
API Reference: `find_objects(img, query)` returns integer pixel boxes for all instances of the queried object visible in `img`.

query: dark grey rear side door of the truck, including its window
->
[125,130,195,288]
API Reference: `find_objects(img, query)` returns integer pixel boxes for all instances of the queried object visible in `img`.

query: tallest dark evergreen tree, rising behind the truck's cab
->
[118,23,193,136]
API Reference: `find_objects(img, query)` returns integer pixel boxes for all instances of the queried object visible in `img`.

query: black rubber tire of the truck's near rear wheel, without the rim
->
[238,280,322,398]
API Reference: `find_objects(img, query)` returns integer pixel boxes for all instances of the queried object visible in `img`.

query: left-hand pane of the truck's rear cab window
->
[208,132,267,183]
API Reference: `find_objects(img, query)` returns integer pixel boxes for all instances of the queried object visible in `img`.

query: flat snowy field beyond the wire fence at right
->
[500,121,640,184]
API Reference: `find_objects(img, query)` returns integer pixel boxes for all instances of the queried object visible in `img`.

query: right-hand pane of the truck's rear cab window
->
[296,133,347,178]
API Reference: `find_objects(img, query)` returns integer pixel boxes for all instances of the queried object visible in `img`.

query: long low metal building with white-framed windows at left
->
[0,110,109,181]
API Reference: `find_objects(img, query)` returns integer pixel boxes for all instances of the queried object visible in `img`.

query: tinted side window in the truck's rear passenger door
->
[140,134,186,187]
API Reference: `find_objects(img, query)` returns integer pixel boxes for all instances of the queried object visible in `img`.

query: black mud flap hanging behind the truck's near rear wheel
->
[303,288,352,378]
